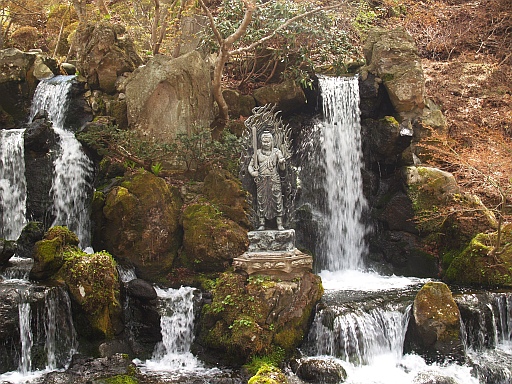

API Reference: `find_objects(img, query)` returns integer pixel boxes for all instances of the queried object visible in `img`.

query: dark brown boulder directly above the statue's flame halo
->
[253,79,307,114]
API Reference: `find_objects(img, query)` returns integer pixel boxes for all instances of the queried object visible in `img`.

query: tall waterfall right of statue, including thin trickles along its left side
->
[301,76,367,271]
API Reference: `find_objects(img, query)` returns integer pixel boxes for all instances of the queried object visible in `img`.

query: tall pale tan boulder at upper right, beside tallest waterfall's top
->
[363,28,425,113]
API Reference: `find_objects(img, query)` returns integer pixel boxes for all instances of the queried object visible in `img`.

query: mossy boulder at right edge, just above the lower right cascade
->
[444,224,512,288]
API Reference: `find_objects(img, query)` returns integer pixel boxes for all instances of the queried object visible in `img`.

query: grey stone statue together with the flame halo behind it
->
[241,105,291,231]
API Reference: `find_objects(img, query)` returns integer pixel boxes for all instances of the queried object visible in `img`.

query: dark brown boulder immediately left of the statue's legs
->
[203,169,251,229]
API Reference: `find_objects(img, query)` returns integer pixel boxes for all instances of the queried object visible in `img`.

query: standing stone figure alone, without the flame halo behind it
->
[247,131,286,231]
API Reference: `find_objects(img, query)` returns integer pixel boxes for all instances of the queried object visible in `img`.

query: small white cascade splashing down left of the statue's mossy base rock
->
[141,287,202,374]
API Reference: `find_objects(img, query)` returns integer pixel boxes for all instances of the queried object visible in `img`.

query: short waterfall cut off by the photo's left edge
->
[0,129,27,240]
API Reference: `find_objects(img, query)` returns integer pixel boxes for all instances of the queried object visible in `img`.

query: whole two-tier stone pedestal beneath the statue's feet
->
[233,229,313,280]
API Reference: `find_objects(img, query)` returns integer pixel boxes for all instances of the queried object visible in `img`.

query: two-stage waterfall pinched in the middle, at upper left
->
[30,76,93,248]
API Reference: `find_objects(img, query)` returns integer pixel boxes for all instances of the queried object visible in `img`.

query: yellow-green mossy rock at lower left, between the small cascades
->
[55,250,122,339]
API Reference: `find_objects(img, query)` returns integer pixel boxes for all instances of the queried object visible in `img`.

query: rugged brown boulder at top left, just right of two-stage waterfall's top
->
[76,22,142,94]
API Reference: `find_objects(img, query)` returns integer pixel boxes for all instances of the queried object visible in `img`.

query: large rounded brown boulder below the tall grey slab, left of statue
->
[93,171,182,282]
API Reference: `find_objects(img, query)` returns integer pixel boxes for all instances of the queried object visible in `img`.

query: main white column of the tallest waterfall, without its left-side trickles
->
[319,77,367,271]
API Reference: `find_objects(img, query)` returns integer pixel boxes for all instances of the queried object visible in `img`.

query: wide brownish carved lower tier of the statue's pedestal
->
[233,248,313,280]
